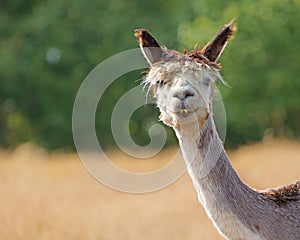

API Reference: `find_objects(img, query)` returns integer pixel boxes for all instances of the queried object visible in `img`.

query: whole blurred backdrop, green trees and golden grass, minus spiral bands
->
[0,0,300,240]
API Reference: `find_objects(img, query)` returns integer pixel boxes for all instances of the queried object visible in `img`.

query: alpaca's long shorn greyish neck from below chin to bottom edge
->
[176,117,264,240]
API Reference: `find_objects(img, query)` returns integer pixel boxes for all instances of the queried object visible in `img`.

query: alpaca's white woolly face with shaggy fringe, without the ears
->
[146,61,219,128]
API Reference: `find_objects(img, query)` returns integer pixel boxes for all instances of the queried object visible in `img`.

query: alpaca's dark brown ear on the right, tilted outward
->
[201,20,237,62]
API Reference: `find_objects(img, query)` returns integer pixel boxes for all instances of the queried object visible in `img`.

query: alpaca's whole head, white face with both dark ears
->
[135,22,235,129]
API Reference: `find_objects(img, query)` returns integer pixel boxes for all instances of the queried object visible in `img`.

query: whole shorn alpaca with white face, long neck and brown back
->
[135,21,300,240]
